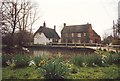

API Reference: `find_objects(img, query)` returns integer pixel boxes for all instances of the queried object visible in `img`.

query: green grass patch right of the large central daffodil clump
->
[67,65,120,79]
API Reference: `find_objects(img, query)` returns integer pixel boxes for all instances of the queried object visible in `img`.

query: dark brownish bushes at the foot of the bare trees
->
[2,31,33,47]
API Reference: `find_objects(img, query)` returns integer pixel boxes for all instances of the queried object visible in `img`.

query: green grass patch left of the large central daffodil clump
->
[2,66,42,79]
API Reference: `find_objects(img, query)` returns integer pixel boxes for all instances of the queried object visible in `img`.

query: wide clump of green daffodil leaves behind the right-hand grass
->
[72,54,105,67]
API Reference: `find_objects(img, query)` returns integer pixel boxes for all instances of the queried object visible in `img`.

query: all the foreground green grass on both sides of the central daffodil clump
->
[2,65,120,79]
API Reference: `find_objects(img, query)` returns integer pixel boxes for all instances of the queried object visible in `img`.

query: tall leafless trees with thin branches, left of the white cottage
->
[1,0,40,46]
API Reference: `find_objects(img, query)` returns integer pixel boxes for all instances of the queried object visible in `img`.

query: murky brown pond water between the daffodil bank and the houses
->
[3,48,94,59]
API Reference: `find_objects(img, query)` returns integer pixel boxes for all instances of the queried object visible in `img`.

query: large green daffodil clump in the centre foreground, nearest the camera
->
[39,57,68,79]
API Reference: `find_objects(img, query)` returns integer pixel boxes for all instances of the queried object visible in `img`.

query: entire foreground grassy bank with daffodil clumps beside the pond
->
[2,50,120,80]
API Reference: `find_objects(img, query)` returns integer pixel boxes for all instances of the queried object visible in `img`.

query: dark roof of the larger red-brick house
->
[61,24,91,33]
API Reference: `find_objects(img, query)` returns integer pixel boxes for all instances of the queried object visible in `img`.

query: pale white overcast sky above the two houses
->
[34,0,119,37]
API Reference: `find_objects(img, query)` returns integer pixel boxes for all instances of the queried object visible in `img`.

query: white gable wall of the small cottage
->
[34,33,52,45]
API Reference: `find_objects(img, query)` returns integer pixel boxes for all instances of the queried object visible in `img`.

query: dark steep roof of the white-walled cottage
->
[34,26,60,39]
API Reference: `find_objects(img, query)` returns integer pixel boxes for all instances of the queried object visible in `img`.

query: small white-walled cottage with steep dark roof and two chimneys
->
[34,22,60,45]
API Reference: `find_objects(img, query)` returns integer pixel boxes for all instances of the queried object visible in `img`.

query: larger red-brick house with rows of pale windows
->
[61,23,101,43]
